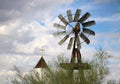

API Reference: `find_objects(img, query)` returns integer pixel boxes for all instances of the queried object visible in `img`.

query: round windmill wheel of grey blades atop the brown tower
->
[53,9,95,50]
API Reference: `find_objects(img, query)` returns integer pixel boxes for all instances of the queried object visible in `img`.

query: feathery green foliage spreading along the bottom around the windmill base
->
[12,49,120,84]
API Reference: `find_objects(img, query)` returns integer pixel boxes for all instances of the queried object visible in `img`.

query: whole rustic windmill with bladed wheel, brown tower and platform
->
[53,9,95,82]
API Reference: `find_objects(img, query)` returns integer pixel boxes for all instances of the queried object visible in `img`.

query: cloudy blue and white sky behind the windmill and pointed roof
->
[0,0,120,84]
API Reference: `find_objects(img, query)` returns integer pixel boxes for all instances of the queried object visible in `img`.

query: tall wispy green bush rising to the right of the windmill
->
[86,49,111,84]
